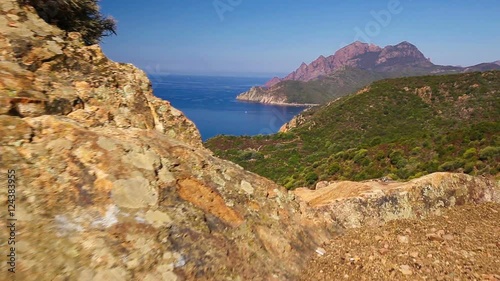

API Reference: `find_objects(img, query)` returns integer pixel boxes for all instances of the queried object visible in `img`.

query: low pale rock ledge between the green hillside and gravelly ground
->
[294,173,500,228]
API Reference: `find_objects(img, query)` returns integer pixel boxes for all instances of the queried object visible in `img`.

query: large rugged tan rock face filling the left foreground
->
[0,0,497,280]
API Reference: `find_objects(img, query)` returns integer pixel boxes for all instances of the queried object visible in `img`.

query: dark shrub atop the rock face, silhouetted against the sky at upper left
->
[19,0,116,45]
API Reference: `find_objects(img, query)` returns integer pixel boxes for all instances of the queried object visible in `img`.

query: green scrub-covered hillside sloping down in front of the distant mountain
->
[205,71,500,188]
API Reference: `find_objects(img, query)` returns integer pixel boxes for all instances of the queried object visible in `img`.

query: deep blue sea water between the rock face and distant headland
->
[150,75,304,141]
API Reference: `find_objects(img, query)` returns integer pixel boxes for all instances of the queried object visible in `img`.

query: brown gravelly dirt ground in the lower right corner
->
[300,203,500,281]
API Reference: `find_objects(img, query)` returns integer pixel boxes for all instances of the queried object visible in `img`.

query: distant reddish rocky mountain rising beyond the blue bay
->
[237,41,500,104]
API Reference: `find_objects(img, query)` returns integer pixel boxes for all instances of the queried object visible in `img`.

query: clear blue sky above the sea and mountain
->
[100,0,500,76]
